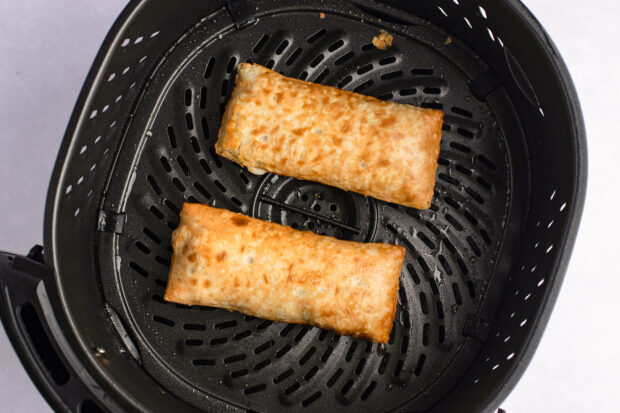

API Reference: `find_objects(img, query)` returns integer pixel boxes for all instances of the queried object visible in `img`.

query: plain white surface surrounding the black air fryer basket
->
[0,0,620,413]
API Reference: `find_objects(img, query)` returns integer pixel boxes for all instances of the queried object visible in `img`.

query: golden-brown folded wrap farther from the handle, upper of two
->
[215,63,443,209]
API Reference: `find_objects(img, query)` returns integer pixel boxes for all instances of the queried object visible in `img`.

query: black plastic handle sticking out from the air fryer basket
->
[0,246,104,413]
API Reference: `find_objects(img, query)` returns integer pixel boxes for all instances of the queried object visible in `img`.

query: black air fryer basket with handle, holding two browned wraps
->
[0,0,586,412]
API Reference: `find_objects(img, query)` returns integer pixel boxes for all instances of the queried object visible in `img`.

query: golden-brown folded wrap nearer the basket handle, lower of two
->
[164,204,405,342]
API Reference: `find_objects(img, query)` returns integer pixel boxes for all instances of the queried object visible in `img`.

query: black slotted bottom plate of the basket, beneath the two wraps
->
[102,4,512,411]
